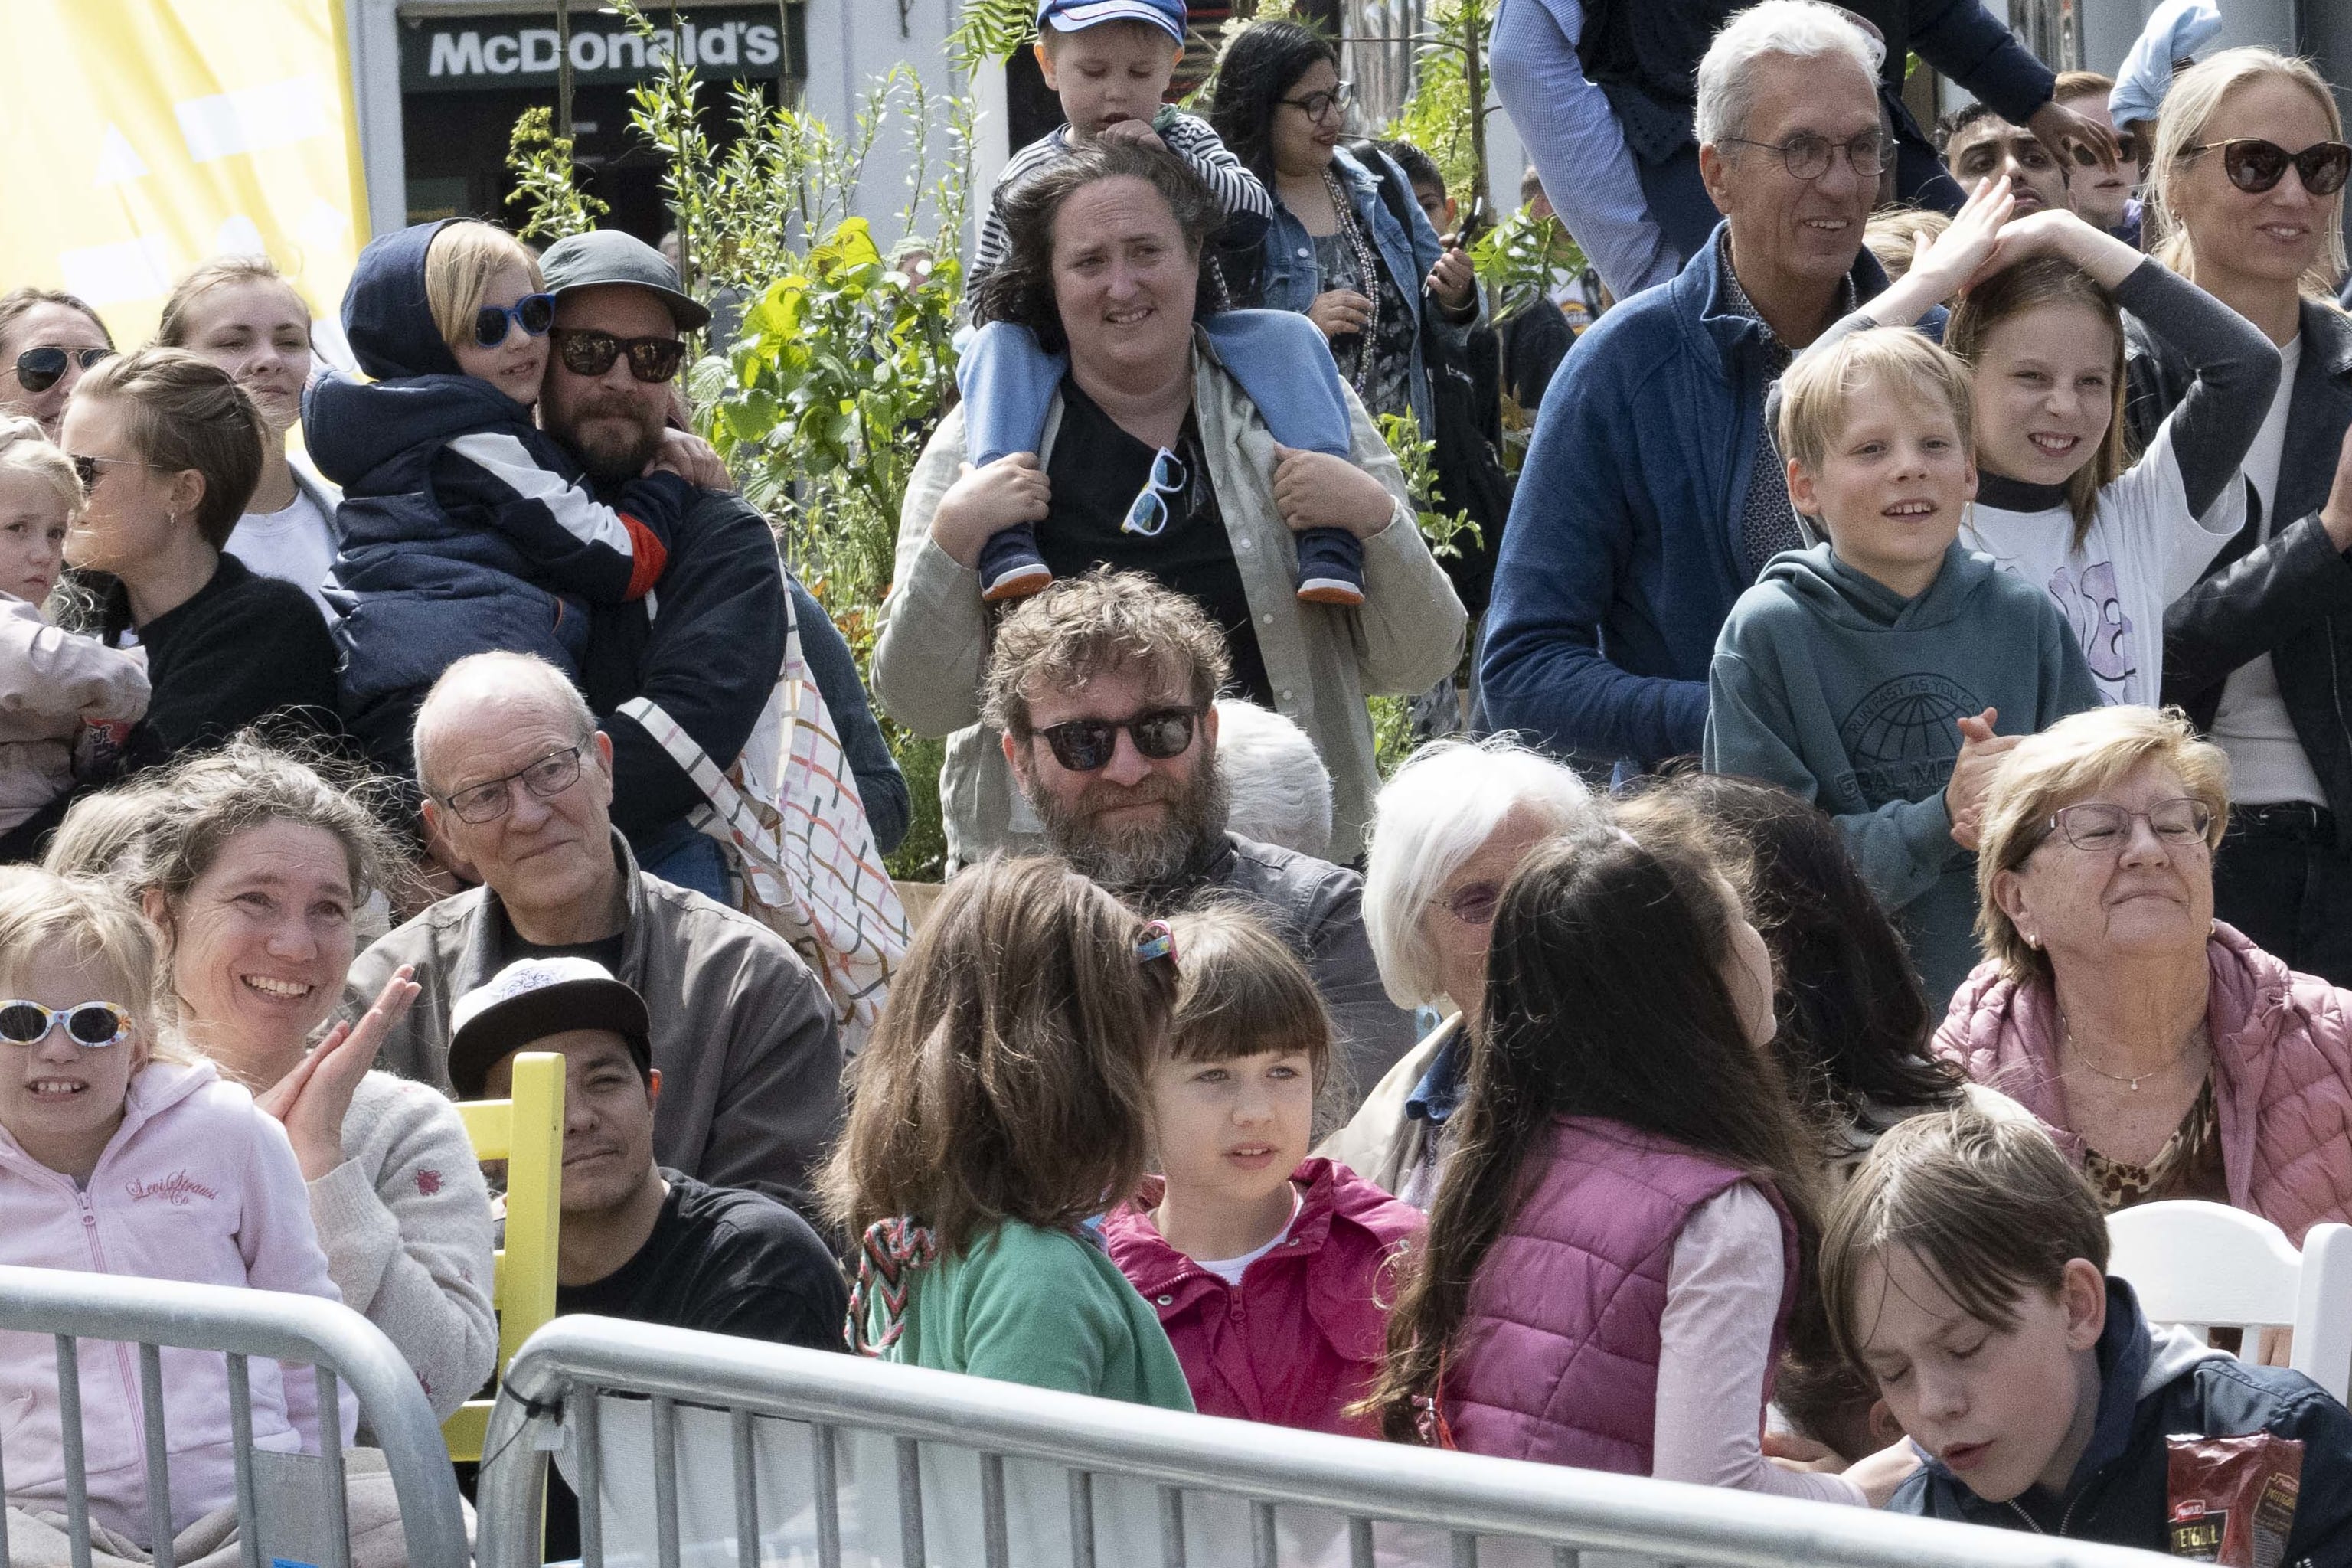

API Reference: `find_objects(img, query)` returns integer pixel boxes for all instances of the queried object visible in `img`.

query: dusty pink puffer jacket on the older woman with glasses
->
[1936,922,2352,1246]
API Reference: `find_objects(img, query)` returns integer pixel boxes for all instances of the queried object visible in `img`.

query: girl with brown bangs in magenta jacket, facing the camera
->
[1103,907,1423,1436]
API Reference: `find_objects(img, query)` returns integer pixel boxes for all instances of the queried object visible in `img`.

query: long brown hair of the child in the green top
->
[818,856,1181,1256]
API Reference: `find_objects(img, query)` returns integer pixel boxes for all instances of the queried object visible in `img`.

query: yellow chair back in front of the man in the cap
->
[443,1050,564,1462]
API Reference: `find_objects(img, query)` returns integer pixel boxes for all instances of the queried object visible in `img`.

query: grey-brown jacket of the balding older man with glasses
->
[344,832,842,1208]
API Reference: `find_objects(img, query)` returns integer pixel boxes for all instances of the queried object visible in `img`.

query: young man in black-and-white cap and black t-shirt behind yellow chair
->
[449,957,849,1561]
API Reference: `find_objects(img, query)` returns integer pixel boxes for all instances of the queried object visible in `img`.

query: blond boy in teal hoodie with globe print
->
[1705,327,2098,1001]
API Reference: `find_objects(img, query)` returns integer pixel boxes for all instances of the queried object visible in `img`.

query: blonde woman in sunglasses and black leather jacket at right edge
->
[2126,49,2352,985]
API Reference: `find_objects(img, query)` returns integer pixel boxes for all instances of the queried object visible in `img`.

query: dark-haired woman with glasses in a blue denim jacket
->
[1209,21,1479,437]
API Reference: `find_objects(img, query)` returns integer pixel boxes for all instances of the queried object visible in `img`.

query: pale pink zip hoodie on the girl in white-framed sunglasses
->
[0,1063,358,1547]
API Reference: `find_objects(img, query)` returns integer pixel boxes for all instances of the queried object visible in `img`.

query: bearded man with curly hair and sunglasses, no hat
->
[981,569,1413,1099]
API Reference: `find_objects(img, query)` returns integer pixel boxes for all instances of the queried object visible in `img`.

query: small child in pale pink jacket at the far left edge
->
[0,419,149,863]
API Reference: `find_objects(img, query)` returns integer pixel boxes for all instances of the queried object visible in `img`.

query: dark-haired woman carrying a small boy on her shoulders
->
[873,141,1463,865]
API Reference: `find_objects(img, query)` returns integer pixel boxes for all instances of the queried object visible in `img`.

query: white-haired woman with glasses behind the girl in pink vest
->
[1315,736,1609,1208]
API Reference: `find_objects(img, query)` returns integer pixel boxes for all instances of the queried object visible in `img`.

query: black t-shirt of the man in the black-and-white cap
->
[555,1168,849,1349]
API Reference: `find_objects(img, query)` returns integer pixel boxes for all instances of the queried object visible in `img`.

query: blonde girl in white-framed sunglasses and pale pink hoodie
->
[0,870,355,1549]
